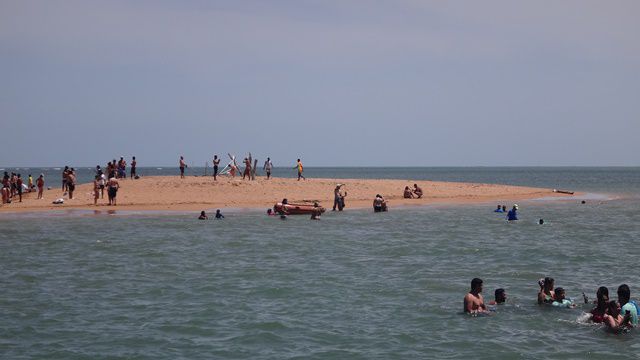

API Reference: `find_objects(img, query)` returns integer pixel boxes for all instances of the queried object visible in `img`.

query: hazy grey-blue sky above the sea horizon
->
[0,0,640,167]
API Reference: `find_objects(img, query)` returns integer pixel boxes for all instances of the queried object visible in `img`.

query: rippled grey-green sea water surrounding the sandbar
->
[0,168,640,359]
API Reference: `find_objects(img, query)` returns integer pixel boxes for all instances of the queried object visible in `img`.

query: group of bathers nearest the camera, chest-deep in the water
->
[463,277,639,332]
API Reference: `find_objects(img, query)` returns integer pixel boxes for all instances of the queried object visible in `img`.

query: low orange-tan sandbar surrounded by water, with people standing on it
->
[0,176,570,212]
